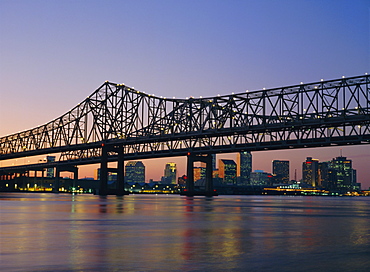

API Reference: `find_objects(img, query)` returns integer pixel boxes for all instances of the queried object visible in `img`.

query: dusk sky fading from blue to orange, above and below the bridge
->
[0,0,370,188]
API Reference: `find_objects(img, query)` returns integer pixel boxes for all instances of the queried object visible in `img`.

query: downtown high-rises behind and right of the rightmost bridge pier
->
[194,152,361,192]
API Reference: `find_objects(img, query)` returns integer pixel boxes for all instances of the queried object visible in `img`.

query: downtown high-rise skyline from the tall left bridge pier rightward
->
[95,151,361,191]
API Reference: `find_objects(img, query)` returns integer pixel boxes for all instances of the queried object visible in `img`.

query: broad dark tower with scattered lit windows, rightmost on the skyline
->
[330,156,356,191]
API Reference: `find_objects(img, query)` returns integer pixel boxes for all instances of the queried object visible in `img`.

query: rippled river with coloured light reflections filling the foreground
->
[0,193,370,271]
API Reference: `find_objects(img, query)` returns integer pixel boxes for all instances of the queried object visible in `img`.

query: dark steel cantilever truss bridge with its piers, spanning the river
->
[0,74,370,194]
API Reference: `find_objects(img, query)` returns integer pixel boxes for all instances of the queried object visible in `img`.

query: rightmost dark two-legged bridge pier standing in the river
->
[183,152,217,196]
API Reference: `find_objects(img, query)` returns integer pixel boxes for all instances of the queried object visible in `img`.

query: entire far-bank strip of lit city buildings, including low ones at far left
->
[1,151,361,195]
